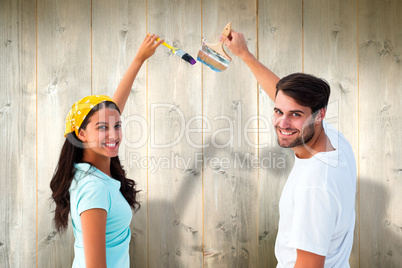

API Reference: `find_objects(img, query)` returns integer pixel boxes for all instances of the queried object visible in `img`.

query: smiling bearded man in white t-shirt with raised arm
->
[221,31,356,268]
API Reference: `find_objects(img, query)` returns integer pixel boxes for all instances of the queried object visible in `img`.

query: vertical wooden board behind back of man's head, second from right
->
[303,0,359,267]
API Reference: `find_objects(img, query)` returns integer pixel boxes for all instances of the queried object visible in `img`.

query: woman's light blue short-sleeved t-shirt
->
[70,163,132,268]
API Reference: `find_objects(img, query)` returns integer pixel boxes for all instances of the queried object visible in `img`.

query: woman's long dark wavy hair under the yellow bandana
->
[50,101,140,233]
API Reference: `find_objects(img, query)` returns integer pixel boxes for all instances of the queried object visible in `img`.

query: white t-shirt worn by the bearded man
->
[275,122,356,268]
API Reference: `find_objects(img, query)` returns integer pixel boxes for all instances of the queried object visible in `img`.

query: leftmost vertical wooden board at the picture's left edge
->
[0,1,36,267]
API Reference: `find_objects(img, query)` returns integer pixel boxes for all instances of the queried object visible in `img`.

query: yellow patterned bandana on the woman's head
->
[64,95,117,137]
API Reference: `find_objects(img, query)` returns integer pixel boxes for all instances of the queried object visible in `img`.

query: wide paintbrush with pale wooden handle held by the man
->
[197,22,232,72]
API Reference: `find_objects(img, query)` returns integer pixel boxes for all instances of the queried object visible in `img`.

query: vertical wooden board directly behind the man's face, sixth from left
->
[258,1,302,267]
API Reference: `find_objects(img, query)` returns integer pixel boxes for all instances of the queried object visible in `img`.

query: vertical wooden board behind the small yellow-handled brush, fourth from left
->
[147,0,203,267]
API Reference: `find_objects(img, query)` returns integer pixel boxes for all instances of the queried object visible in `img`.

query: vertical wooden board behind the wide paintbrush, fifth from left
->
[202,1,258,267]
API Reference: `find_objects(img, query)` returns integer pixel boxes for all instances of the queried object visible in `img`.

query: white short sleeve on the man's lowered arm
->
[290,187,339,256]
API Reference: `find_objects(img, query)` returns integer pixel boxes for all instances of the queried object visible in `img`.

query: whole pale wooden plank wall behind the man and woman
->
[0,0,402,268]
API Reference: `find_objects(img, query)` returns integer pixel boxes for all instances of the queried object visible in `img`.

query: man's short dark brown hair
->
[275,73,331,113]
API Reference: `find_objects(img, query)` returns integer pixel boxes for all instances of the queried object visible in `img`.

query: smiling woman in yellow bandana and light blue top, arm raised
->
[50,35,163,268]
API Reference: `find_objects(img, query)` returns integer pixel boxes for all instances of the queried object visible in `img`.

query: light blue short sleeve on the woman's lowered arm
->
[77,178,110,215]
